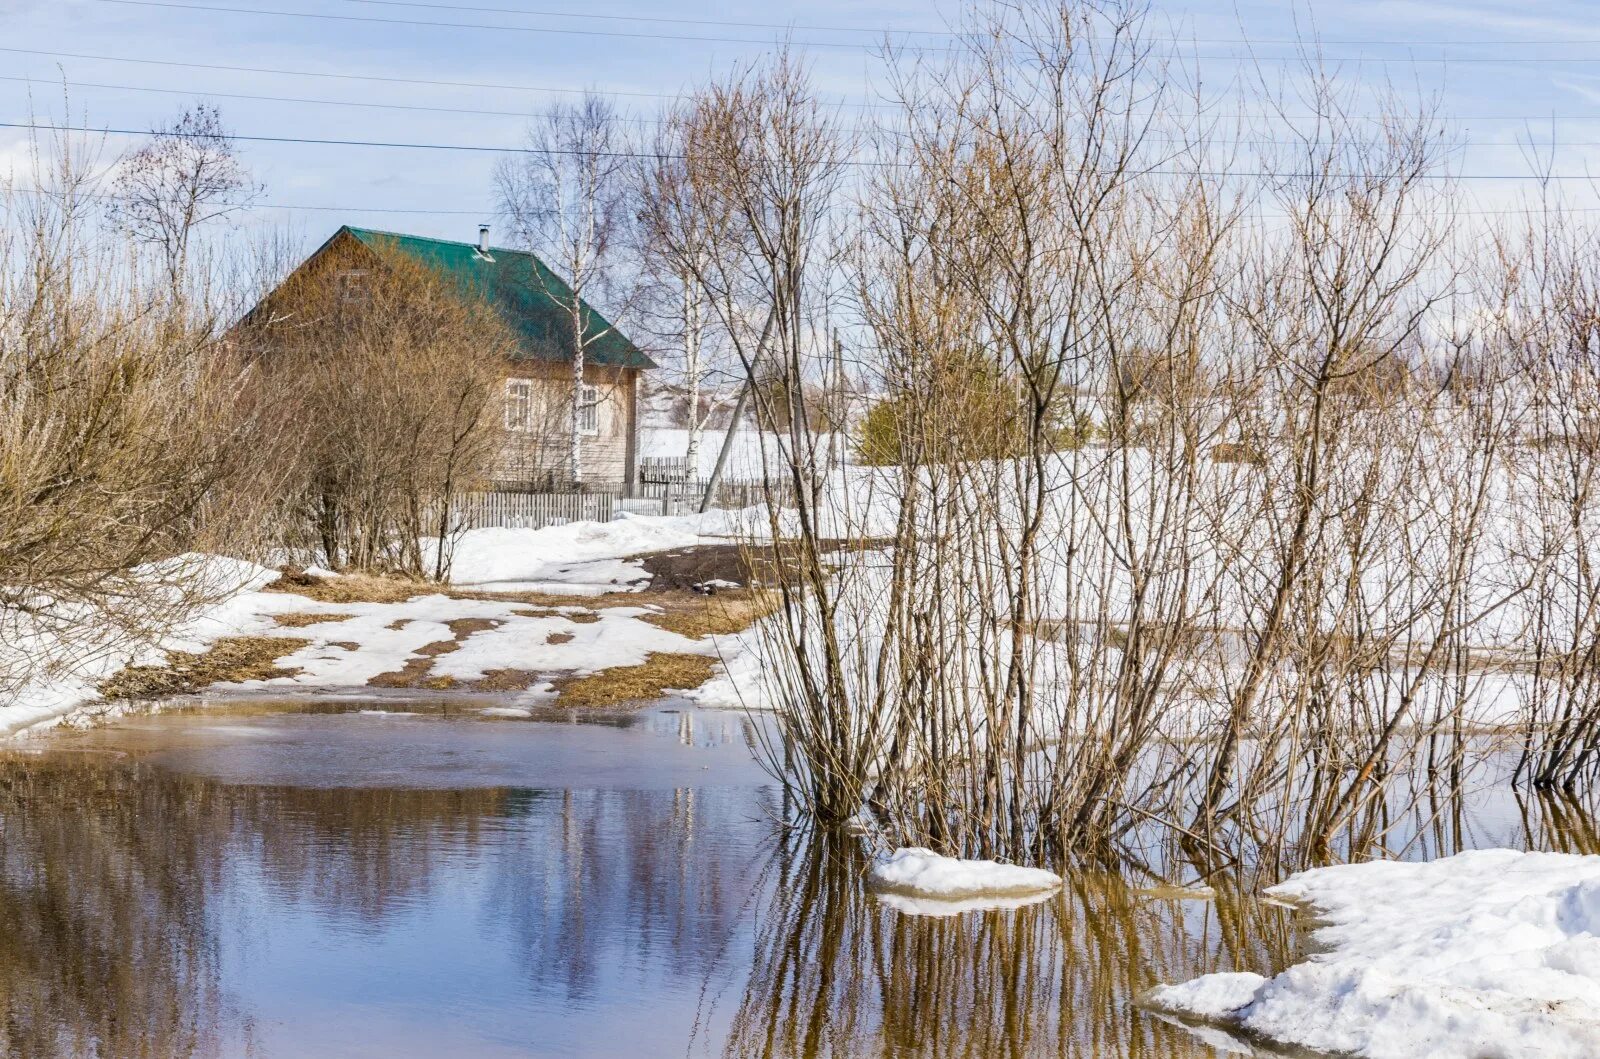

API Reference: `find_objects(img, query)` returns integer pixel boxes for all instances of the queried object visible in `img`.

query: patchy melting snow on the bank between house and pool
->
[0,512,754,736]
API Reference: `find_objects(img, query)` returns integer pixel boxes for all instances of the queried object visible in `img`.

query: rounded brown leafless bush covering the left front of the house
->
[238,241,515,581]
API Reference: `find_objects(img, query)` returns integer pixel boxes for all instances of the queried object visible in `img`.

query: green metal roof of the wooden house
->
[340,226,656,368]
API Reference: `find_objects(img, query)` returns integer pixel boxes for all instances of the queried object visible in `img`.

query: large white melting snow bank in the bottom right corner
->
[1146,849,1600,1059]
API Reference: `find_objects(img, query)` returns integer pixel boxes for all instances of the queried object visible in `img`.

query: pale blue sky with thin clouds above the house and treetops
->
[0,0,1600,238]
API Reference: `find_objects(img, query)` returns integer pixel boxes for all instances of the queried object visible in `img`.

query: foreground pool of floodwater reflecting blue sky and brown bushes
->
[0,701,1568,1059]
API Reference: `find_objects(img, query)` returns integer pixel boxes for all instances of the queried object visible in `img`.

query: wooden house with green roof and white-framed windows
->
[246,226,656,493]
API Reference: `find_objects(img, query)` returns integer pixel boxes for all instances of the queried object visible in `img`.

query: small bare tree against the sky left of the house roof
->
[110,102,264,294]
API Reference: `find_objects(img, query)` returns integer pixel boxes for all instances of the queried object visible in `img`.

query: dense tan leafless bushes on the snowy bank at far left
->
[0,122,256,704]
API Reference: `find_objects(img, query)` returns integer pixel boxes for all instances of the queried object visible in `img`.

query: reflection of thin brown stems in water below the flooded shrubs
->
[722,841,1294,1057]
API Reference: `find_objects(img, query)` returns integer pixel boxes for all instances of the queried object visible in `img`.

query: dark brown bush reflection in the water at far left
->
[0,760,222,1056]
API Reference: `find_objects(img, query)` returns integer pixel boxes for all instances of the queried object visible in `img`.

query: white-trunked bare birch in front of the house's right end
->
[494,94,632,488]
